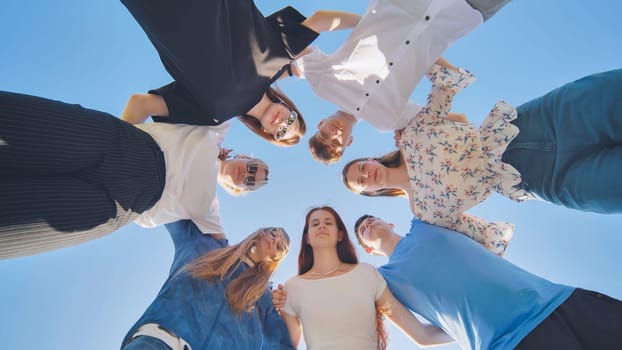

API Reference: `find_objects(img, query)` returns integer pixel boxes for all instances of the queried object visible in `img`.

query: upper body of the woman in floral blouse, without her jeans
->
[342,62,522,255]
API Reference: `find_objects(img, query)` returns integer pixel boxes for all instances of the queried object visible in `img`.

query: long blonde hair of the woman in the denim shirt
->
[186,227,289,313]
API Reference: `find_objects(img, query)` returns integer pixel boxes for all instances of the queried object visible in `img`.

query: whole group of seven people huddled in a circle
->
[0,0,622,350]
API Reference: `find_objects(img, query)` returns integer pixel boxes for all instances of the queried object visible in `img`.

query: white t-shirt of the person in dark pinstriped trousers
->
[134,122,231,233]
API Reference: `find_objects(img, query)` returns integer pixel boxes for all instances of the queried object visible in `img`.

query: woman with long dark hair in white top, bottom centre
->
[275,206,451,350]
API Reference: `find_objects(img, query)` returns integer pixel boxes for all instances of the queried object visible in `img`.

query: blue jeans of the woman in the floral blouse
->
[503,69,622,213]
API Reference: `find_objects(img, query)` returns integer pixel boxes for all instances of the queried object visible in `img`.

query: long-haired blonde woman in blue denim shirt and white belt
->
[121,220,294,350]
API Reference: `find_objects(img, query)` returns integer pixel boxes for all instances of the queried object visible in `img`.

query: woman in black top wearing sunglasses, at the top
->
[122,0,359,146]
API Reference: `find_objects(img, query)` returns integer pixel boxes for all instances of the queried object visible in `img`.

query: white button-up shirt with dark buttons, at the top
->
[296,0,483,131]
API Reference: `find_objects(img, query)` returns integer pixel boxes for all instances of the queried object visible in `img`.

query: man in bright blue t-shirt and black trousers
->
[355,215,622,350]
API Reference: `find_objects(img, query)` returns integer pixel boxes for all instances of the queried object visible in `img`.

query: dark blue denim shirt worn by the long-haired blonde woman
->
[122,220,294,350]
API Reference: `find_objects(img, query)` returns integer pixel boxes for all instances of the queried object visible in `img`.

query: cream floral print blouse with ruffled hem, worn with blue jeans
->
[399,65,527,255]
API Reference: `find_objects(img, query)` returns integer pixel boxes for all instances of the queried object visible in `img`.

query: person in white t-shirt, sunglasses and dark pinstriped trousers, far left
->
[0,92,269,258]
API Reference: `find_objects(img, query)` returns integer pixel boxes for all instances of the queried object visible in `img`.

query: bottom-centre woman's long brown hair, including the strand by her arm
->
[298,206,387,350]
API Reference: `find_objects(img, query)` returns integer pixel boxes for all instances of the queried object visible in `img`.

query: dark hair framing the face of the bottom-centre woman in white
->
[298,206,359,275]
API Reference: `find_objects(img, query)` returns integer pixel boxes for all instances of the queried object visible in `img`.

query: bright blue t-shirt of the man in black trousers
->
[379,219,574,349]
